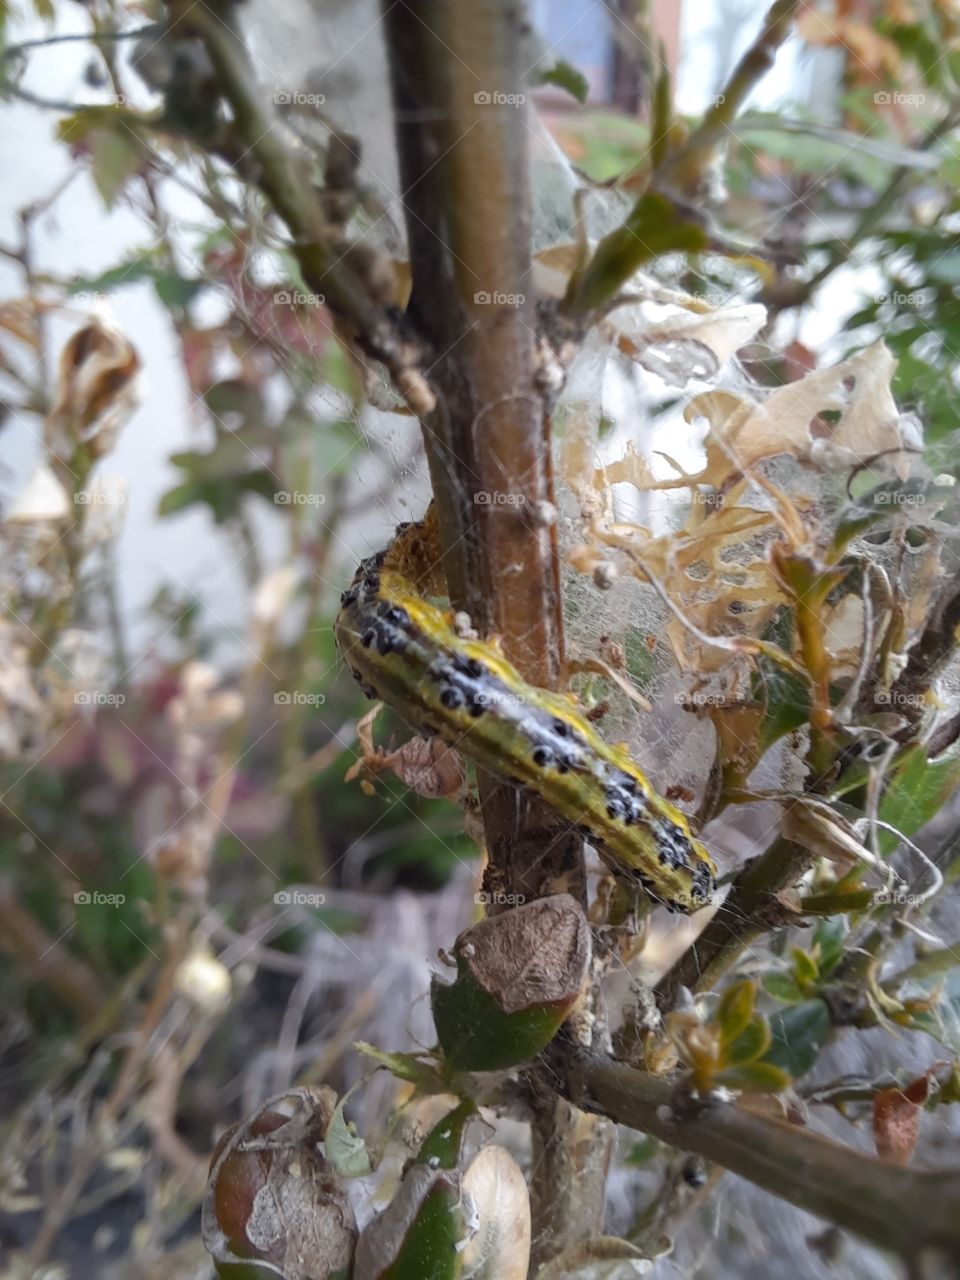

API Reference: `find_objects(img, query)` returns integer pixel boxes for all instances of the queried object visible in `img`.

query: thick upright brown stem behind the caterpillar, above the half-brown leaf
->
[385,0,584,899]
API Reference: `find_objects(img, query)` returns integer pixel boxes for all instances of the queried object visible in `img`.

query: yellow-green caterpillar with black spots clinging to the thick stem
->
[334,525,717,913]
